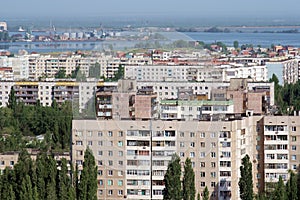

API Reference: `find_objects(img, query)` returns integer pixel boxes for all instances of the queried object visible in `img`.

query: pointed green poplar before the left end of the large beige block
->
[78,148,97,200]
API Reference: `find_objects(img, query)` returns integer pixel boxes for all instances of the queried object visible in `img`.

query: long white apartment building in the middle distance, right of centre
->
[124,63,268,82]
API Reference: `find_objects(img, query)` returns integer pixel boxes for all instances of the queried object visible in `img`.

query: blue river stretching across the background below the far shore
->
[0,32,300,53]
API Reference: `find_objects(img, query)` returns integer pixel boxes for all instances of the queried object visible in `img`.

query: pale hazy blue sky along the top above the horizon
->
[0,0,300,19]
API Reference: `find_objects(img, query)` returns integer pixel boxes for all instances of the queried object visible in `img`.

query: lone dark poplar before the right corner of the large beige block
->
[239,154,253,200]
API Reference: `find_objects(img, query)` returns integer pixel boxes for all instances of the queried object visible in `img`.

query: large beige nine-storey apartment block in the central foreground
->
[72,116,263,199]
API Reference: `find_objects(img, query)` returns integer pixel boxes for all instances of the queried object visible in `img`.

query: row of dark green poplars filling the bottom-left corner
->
[0,151,97,200]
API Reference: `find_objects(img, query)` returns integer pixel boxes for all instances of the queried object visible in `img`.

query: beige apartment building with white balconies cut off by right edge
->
[260,113,300,192]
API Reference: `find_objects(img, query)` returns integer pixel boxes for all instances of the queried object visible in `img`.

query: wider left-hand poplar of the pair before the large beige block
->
[163,154,182,200]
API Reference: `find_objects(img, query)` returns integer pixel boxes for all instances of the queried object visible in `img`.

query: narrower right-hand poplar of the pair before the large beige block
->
[182,158,196,200]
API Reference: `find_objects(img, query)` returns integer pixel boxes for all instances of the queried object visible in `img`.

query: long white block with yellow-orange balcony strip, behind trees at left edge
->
[0,80,105,111]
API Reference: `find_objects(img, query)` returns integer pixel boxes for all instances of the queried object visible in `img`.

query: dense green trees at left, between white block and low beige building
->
[0,88,72,152]
